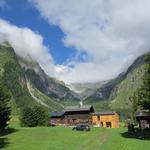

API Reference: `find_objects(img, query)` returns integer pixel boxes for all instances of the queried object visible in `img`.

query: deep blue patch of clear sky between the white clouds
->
[0,0,75,64]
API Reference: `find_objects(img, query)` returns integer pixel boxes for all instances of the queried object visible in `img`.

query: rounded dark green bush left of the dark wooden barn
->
[20,106,48,127]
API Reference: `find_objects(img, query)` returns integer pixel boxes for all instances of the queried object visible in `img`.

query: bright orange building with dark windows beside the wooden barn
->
[92,112,119,128]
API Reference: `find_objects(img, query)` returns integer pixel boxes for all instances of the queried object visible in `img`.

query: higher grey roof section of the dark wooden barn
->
[64,105,94,112]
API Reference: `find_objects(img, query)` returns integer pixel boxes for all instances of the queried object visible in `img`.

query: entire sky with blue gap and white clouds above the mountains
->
[0,0,150,83]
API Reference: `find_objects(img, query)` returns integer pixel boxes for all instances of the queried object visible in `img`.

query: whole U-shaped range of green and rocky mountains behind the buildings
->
[0,42,146,114]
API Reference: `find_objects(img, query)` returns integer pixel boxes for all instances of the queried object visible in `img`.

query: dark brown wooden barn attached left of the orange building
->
[50,105,94,126]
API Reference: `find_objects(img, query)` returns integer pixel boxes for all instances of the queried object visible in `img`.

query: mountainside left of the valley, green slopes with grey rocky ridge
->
[0,43,78,112]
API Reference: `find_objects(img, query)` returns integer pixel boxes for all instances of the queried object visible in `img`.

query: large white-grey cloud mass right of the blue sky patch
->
[29,0,150,82]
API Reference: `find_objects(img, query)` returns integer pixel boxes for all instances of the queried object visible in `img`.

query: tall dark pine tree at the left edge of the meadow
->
[0,81,11,132]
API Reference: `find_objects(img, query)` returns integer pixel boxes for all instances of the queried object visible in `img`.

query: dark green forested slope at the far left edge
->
[0,42,34,107]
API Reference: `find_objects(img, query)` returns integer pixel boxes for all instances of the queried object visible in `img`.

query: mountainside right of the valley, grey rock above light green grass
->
[81,54,146,117]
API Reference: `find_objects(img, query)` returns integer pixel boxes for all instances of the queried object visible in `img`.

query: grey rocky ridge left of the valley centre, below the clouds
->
[18,57,79,101]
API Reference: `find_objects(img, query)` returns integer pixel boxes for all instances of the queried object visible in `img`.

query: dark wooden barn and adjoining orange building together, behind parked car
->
[50,105,119,128]
